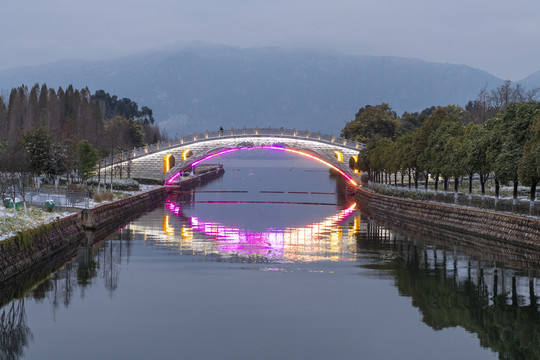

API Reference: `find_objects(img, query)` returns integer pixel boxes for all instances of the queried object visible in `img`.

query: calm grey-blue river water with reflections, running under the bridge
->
[0,150,540,359]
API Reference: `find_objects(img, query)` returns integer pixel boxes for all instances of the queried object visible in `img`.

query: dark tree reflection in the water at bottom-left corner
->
[0,300,34,360]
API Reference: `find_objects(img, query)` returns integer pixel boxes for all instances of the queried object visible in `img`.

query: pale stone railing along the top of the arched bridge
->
[99,127,362,168]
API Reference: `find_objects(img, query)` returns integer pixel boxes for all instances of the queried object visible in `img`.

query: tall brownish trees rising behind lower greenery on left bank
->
[0,84,163,156]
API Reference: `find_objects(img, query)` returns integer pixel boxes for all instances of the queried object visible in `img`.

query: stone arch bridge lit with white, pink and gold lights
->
[97,128,364,185]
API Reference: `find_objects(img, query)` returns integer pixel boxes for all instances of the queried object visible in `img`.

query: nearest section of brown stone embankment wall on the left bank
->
[0,216,85,283]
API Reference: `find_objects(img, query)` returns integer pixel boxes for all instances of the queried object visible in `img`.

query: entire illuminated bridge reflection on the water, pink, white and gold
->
[125,202,361,262]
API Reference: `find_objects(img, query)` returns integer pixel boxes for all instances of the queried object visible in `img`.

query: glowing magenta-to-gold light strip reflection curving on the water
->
[166,202,356,258]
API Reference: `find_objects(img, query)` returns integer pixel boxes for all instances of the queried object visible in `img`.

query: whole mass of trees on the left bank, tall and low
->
[0,84,165,198]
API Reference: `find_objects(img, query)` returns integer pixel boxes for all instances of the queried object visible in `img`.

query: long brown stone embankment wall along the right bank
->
[355,188,540,252]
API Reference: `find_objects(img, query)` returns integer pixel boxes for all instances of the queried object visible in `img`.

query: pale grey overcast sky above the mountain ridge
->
[0,0,540,81]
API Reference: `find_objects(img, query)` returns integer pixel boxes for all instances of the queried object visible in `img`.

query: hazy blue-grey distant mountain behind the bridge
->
[0,45,502,136]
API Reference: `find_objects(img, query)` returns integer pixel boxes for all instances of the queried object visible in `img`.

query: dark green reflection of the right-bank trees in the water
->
[357,223,540,359]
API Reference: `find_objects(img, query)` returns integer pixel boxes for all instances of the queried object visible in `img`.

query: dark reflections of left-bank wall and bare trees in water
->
[0,225,134,360]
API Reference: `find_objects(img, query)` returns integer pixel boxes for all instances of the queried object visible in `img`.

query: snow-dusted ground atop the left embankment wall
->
[0,185,159,241]
